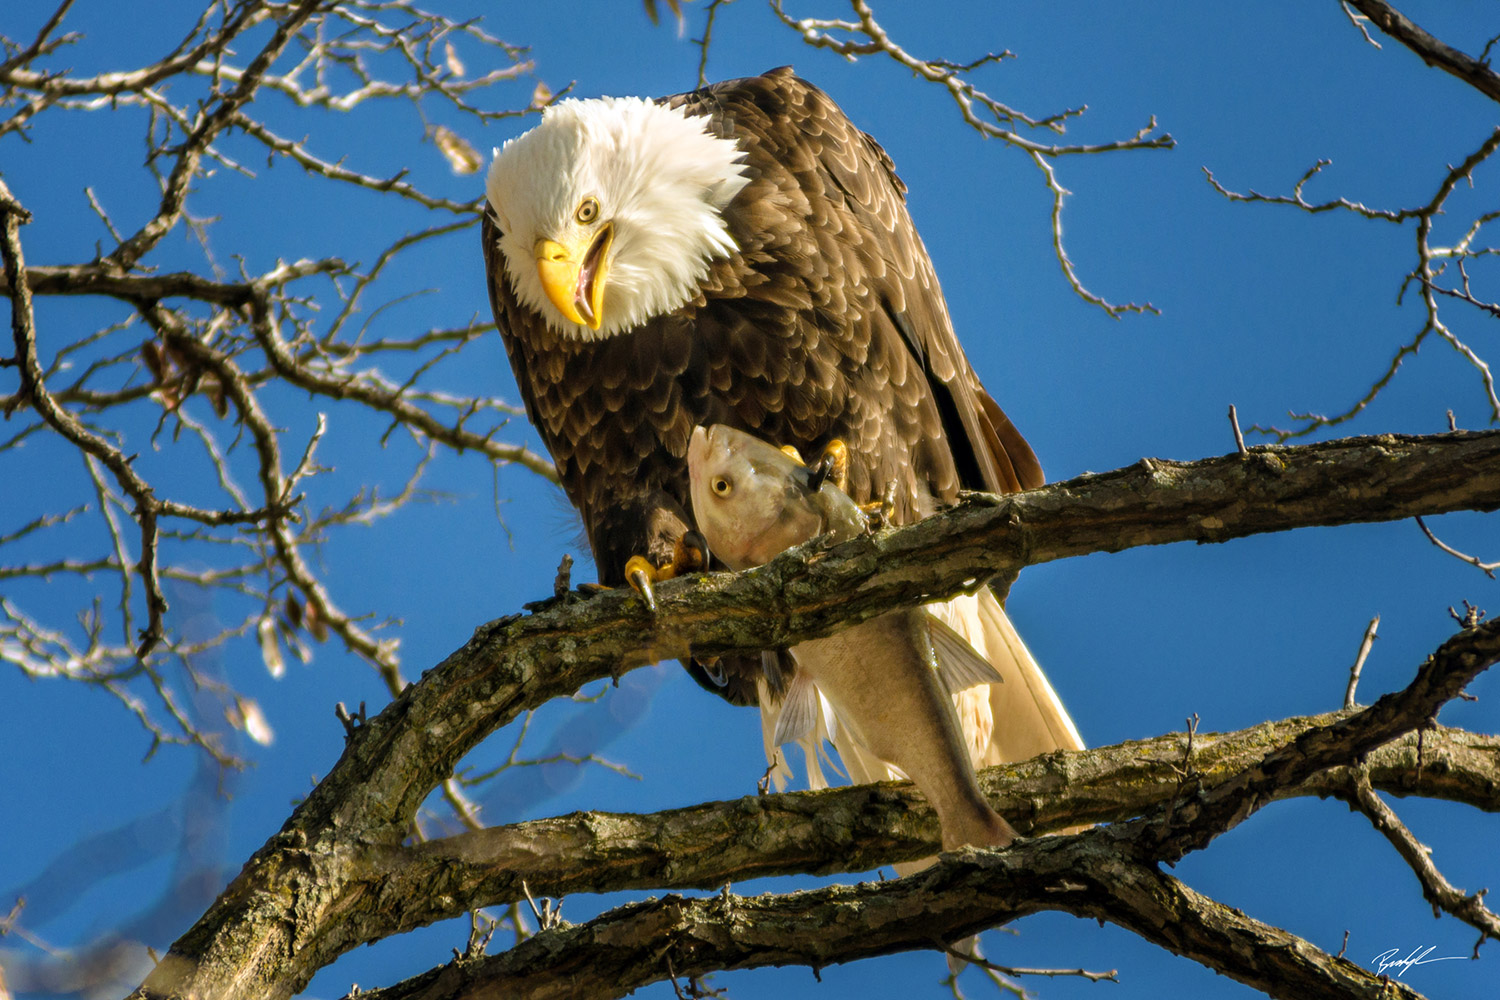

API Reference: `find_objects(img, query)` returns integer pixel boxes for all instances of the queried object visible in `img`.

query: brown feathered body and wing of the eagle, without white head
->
[483,69,1043,703]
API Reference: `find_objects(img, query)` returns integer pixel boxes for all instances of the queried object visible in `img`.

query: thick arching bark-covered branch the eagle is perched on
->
[129,432,1500,999]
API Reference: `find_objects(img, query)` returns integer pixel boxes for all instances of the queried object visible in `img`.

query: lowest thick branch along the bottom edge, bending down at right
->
[348,829,1418,1000]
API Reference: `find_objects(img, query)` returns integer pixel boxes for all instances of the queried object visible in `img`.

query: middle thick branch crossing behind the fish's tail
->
[310,712,1500,940]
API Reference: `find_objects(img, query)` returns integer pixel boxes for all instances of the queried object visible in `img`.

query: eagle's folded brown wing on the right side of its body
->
[672,67,1043,514]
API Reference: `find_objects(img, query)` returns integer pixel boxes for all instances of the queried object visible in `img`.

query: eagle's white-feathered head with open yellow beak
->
[485,97,747,339]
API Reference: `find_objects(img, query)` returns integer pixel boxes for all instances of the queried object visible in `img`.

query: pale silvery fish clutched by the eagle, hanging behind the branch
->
[687,424,1044,850]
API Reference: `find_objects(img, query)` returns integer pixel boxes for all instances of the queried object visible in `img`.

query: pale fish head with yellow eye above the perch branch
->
[687,424,824,570]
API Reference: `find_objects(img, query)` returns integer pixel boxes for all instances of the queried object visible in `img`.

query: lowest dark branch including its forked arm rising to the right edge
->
[316,611,1500,1000]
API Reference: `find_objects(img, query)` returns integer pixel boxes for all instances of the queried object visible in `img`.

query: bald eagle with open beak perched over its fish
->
[483,67,1082,759]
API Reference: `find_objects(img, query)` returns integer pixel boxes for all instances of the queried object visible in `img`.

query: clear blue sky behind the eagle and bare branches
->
[0,0,1500,1000]
